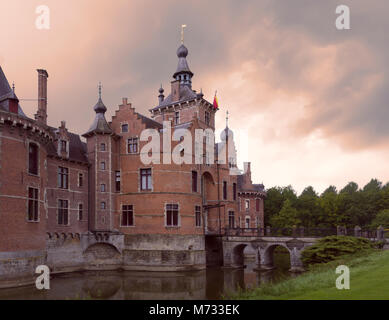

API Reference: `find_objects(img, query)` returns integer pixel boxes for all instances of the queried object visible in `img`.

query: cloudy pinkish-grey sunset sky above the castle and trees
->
[0,0,389,193]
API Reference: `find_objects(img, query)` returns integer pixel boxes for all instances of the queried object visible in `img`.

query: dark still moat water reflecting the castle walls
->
[0,253,292,300]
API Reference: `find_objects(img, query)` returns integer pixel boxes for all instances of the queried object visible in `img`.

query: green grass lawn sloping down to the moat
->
[231,251,389,300]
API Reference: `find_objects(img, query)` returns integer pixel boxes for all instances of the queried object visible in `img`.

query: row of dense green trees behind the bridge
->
[264,179,389,229]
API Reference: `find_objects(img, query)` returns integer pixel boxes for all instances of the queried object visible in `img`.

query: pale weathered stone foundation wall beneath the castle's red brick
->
[0,233,206,288]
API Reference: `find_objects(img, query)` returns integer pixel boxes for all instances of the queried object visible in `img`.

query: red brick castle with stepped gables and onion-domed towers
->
[0,39,266,288]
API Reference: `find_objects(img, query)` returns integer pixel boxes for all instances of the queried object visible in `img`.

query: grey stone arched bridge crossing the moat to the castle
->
[222,236,318,272]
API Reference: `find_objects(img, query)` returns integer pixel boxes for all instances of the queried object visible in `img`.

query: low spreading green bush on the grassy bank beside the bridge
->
[301,236,375,265]
